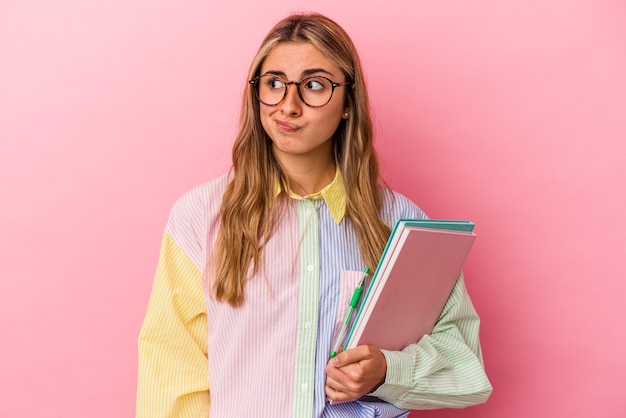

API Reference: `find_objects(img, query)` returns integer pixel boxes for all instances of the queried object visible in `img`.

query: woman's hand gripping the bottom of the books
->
[326,345,387,402]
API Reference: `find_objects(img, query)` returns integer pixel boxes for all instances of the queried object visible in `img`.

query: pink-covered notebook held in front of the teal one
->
[345,224,476,351]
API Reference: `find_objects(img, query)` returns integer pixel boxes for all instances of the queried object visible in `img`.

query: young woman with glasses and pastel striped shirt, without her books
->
[137,14,491,418]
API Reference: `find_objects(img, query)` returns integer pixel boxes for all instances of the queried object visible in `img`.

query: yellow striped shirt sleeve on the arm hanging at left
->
[137,232,210,418]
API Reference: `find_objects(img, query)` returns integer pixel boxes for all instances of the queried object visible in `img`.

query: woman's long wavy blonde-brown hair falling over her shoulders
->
[209,13,391,307]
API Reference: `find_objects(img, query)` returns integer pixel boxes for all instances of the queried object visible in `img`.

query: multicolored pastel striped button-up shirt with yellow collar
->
[137,174,491,418]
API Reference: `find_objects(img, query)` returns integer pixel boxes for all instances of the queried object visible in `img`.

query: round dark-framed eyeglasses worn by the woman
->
[248,74,352,107]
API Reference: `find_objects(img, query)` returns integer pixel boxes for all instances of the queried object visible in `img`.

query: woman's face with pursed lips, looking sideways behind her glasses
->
[260,42,350,167]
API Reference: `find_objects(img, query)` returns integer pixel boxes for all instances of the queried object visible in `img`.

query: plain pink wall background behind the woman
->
[0,0,626,418]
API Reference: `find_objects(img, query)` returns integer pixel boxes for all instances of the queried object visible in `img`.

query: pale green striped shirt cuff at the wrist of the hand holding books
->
[369,350,413,401]
